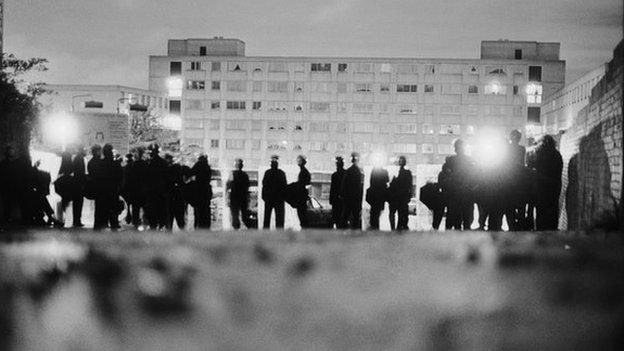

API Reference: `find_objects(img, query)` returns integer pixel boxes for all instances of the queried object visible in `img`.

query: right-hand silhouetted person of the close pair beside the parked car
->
[340,152,364,230]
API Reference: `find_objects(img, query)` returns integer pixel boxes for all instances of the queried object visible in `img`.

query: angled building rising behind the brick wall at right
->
[534,64,607,136]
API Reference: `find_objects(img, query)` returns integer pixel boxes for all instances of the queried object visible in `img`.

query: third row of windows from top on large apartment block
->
[174,99,524,117]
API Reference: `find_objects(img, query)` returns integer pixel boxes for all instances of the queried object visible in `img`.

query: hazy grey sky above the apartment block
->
[4,0,622,88]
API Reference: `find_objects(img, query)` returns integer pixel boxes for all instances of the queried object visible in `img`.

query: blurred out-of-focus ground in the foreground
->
[0,231,624,350]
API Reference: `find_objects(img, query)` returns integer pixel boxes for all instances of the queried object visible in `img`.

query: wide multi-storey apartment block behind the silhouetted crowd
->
[149,37,565,172]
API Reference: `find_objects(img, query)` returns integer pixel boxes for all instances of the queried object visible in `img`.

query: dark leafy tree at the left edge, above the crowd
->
[0,55,47,161]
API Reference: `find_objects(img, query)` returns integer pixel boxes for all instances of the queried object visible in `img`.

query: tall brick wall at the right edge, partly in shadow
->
[559,42,624,229]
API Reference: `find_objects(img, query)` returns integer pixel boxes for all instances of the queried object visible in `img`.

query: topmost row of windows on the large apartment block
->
[170,61,542,82]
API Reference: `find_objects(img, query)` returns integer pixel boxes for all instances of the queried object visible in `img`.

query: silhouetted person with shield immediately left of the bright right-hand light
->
[440,139,475,230]
